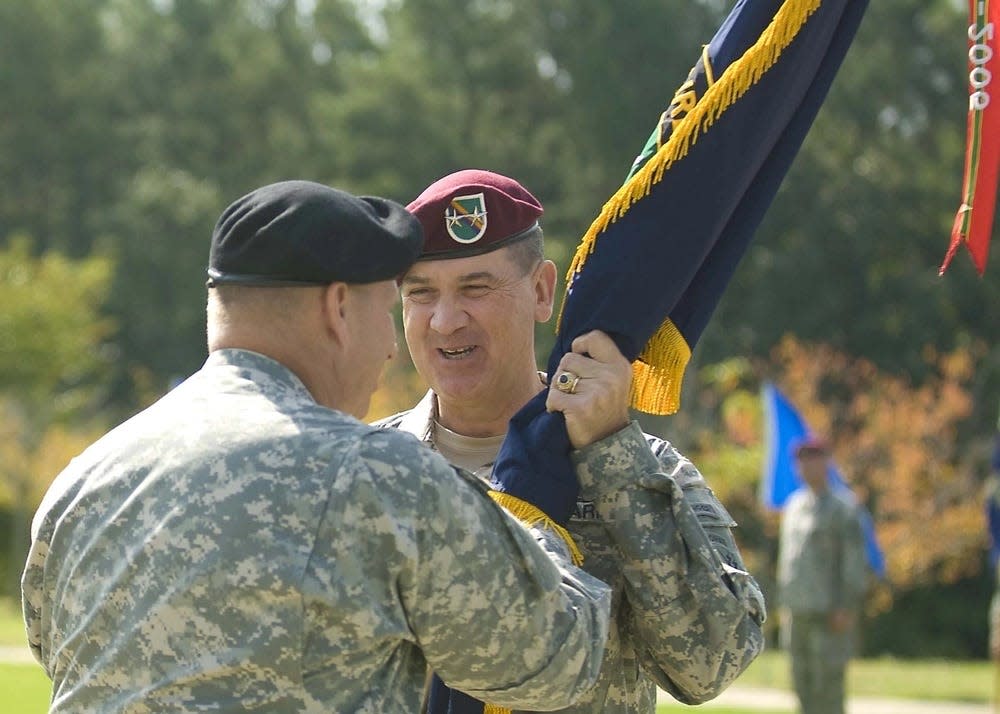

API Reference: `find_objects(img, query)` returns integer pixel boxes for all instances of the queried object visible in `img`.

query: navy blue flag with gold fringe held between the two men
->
[493,0,867,523]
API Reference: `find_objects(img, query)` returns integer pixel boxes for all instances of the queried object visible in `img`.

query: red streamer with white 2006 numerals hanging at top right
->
[938,0,1000,275]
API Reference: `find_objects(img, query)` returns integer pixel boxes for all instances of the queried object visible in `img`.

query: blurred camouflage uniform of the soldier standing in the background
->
[778,487,868,714]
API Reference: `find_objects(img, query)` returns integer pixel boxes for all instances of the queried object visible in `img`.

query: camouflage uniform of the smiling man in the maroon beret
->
[378,392,764,714]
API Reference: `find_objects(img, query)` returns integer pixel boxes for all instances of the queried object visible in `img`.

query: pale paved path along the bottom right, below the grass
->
[660,686,995,714]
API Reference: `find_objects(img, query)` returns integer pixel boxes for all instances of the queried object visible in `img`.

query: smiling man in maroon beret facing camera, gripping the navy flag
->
[379,169,764,714]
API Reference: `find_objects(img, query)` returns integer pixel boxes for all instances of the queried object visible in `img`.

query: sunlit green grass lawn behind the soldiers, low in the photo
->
[0,599,998,714]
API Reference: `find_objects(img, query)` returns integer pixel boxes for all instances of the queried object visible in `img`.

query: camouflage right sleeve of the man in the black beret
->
[344,432,611,709]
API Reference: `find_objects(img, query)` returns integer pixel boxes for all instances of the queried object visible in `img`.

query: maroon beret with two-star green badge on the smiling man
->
[406,169,542,260]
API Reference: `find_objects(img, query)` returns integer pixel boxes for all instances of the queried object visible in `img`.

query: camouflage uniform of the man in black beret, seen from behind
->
[22,350,610,714]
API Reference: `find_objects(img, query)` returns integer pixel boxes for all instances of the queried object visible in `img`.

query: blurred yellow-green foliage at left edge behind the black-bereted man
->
[0,238,112,588]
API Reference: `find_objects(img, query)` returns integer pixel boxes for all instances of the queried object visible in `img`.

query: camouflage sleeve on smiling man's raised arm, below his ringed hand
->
[574,422,765,704]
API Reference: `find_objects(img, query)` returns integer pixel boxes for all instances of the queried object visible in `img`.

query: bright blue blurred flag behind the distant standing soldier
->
[760,382,888,578]
